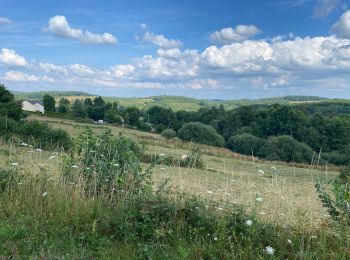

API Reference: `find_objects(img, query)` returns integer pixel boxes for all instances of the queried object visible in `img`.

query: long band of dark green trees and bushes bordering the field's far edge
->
[30,92,350,165]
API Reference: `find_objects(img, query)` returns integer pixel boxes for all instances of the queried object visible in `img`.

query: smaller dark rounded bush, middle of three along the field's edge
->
[226,134,265,156]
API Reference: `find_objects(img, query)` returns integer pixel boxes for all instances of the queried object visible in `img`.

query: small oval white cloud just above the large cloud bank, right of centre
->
[210,25,261,44]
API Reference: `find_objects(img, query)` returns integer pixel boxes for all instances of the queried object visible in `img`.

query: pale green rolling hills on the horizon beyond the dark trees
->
[14,91,350,113]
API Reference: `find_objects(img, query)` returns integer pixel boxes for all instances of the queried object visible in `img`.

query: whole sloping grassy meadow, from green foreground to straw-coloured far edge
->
[0,115,350,259]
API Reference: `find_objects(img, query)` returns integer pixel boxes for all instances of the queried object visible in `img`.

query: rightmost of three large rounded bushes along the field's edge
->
[261,135,314,163]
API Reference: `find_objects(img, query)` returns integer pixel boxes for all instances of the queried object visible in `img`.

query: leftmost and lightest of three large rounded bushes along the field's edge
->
[178,122,225,147]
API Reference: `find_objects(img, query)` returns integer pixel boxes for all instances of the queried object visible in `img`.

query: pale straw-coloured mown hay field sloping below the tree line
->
[23,116,337,231]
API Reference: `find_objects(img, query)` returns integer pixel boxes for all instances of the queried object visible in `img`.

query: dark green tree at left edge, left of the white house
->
[0,84,23,120]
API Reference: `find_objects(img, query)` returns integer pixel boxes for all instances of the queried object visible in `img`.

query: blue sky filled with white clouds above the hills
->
[0,0,350,99]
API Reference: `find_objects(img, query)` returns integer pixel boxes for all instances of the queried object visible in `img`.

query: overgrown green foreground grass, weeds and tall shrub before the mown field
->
[0,128,350,259]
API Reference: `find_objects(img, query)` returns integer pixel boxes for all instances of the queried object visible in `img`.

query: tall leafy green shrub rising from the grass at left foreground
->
[64,129,151,194]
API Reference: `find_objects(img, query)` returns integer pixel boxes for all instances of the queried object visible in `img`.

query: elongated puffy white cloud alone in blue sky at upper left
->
[45,15,117,44]
